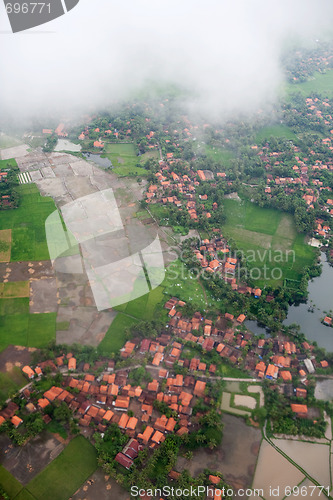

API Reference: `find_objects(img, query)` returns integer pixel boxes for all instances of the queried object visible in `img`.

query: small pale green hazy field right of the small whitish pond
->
[104,143,149,177]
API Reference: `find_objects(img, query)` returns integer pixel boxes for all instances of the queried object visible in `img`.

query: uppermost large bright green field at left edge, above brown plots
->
[0,184,56,261]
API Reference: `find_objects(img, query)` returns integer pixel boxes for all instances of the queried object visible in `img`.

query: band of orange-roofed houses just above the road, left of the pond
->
[165,298,329,386]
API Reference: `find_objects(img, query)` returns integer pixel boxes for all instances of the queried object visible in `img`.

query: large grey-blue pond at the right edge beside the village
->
[284,253,333,352]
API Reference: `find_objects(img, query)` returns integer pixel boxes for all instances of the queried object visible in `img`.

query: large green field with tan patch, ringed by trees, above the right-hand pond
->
[222,199,314,288]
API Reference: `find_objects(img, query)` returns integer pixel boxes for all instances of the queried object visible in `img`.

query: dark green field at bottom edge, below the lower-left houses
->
[26,436,97,500]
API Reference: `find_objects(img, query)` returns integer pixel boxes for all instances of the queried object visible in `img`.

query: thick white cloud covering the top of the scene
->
[0,0,333,119]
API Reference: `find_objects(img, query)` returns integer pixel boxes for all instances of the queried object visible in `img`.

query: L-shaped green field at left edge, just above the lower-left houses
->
[0,298,56,350]
